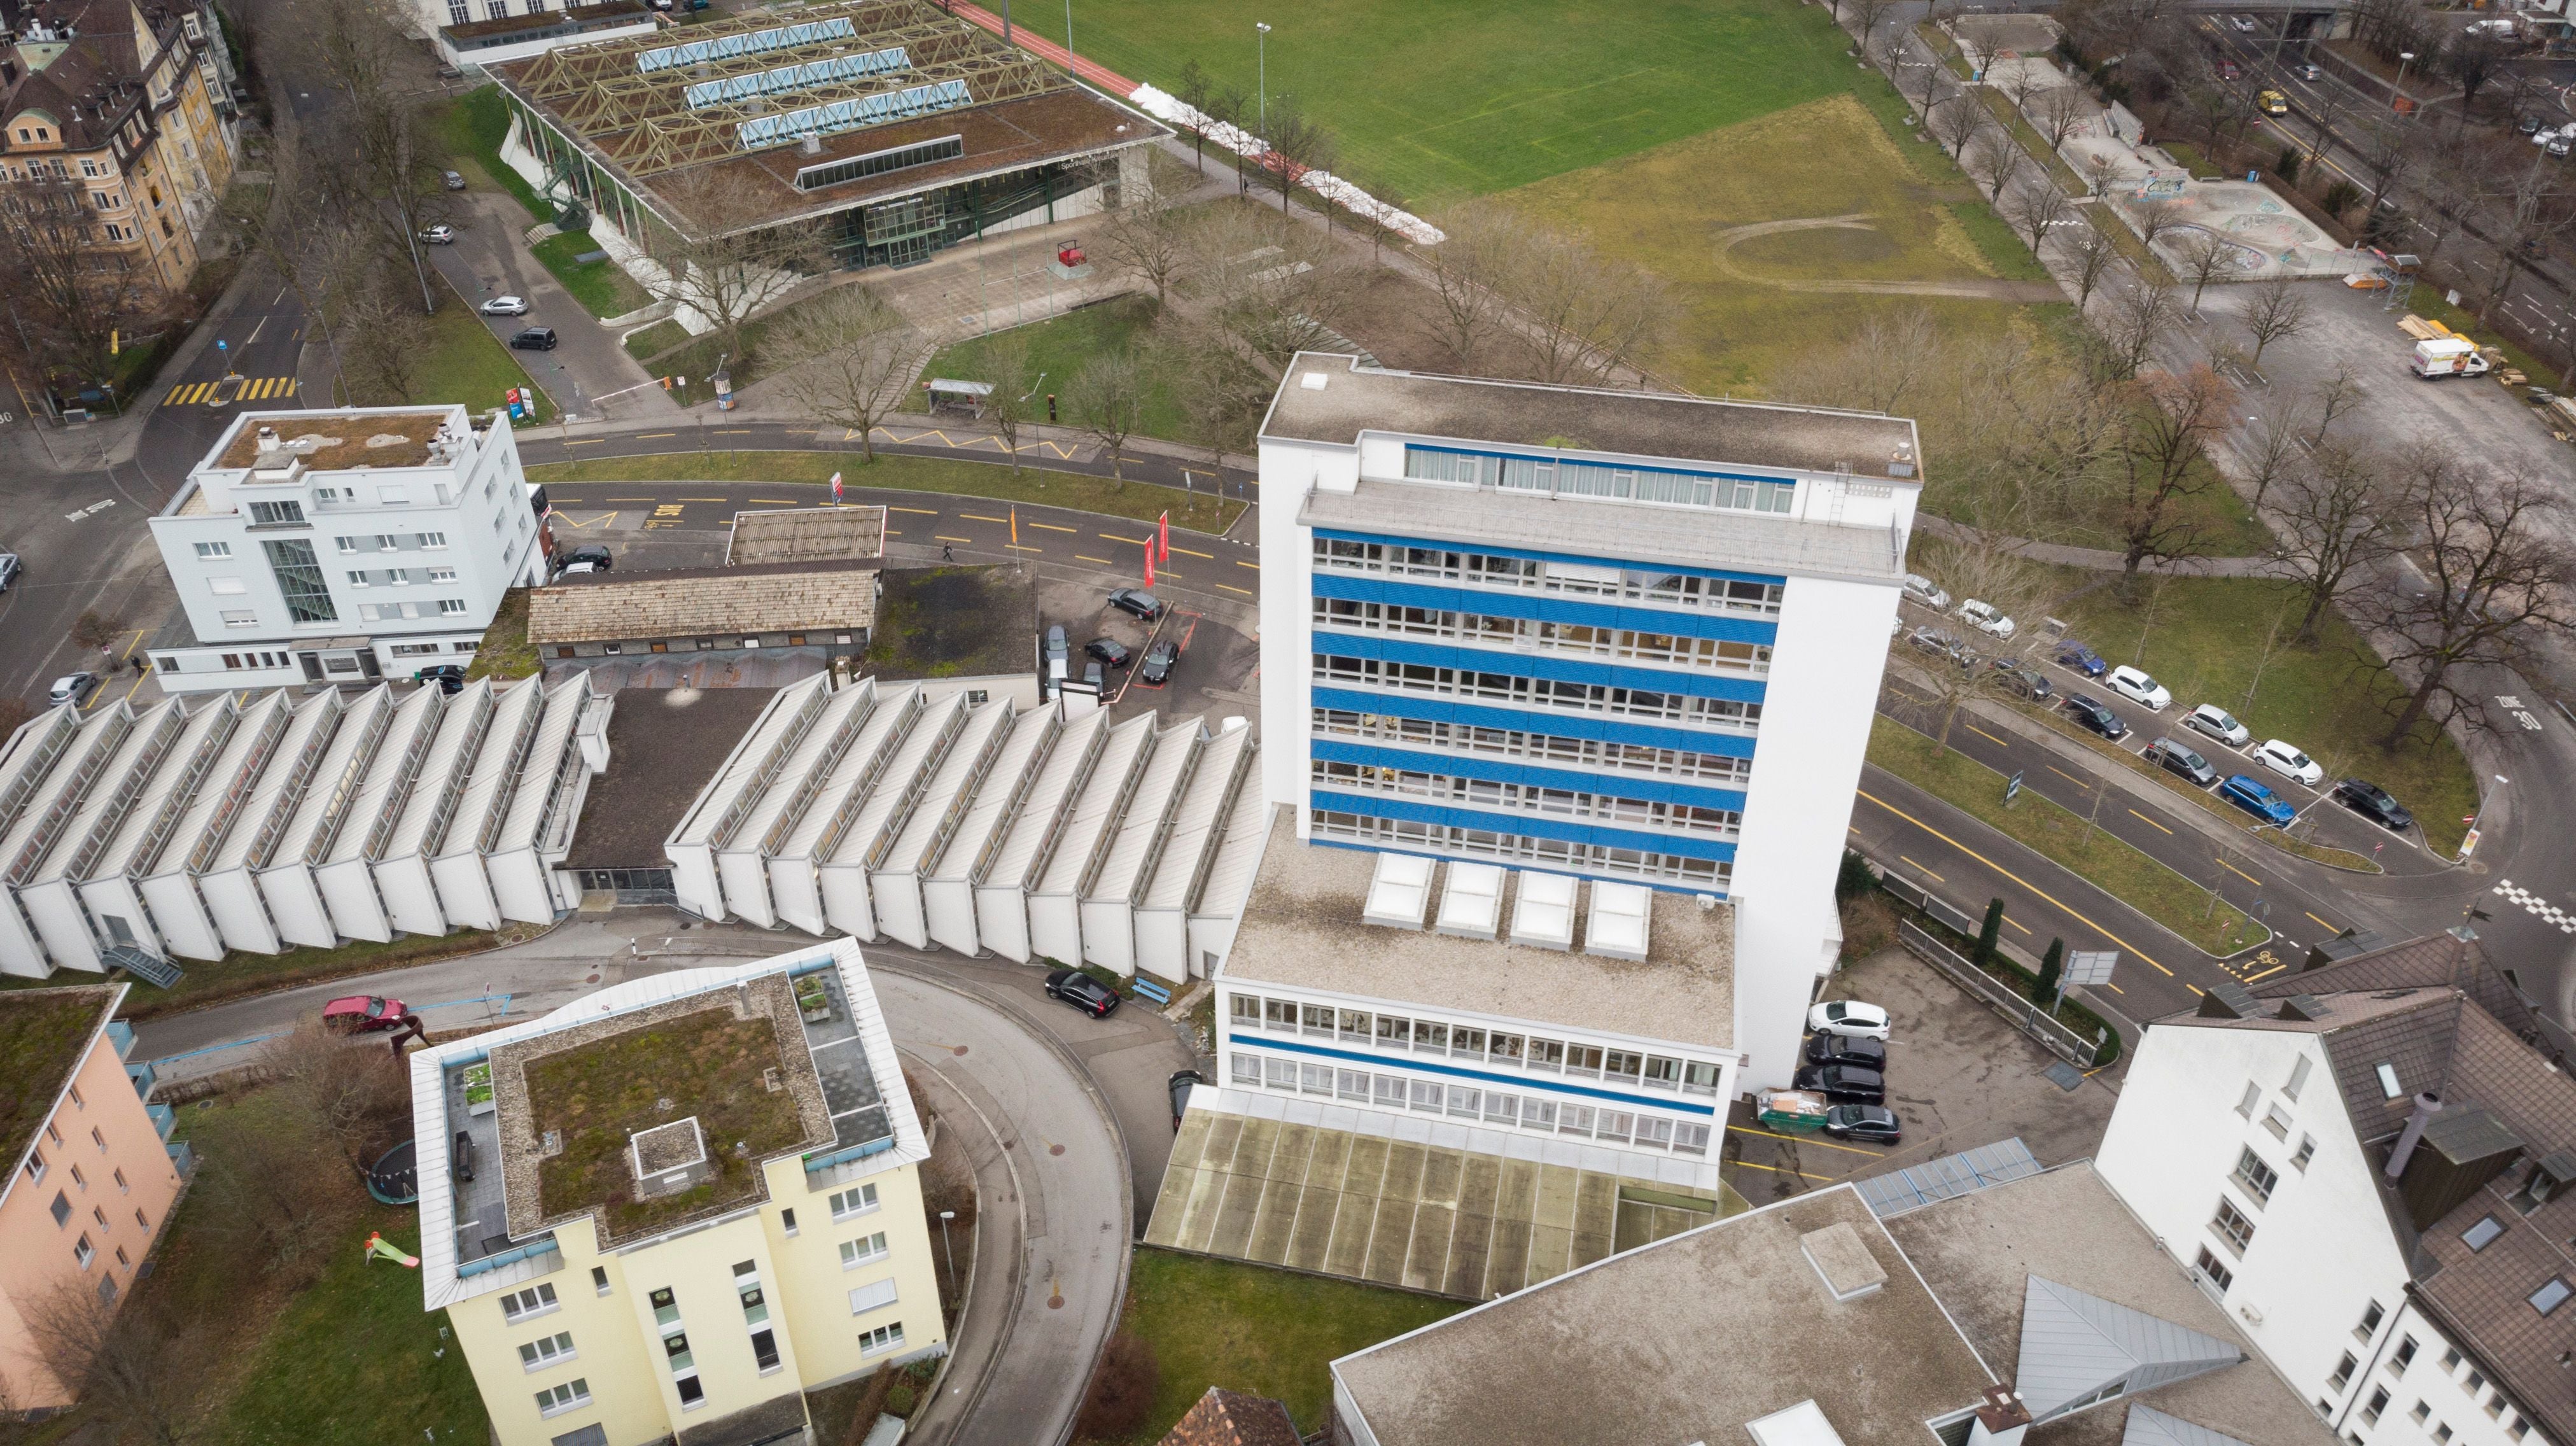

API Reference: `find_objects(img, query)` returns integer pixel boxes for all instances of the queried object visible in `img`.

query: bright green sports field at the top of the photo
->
[991,0,1855,209]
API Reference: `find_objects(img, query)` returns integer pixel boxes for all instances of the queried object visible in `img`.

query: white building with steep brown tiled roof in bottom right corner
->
[2097,933,2576,1446]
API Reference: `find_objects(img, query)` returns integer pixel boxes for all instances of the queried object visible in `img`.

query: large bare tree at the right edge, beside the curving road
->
[2370,469,2576,753]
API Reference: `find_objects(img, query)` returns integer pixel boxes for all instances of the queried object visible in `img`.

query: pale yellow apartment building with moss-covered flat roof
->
[412,938,948,1446]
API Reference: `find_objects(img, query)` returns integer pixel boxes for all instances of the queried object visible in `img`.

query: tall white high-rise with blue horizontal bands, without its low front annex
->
[1259,353,1922,1088]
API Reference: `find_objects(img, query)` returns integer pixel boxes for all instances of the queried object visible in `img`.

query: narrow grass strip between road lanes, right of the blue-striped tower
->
[1870,717,2269,953]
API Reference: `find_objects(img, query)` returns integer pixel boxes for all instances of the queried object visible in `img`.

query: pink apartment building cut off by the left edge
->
[0,985,191,1412]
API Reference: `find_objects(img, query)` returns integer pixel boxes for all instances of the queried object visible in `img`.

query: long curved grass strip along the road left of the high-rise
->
[528,449,1244,531]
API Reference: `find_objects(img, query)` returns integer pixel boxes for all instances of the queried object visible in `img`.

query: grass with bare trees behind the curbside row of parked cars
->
[2058,577,2478,859]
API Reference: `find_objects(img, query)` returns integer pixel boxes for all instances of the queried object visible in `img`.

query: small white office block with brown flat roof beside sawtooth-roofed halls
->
[150,407,549,693]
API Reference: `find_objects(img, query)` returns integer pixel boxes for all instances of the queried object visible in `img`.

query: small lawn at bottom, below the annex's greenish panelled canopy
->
[1092,1250,1466,1443]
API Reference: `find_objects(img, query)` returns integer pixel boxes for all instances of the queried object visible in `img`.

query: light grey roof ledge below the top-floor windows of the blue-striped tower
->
[1296,479,1907,582]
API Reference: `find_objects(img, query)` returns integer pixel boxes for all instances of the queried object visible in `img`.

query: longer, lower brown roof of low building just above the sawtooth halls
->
[528,562,876,647]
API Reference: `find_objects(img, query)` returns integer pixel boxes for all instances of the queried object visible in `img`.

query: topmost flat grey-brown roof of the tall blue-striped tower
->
[1263,353,1922,479]
